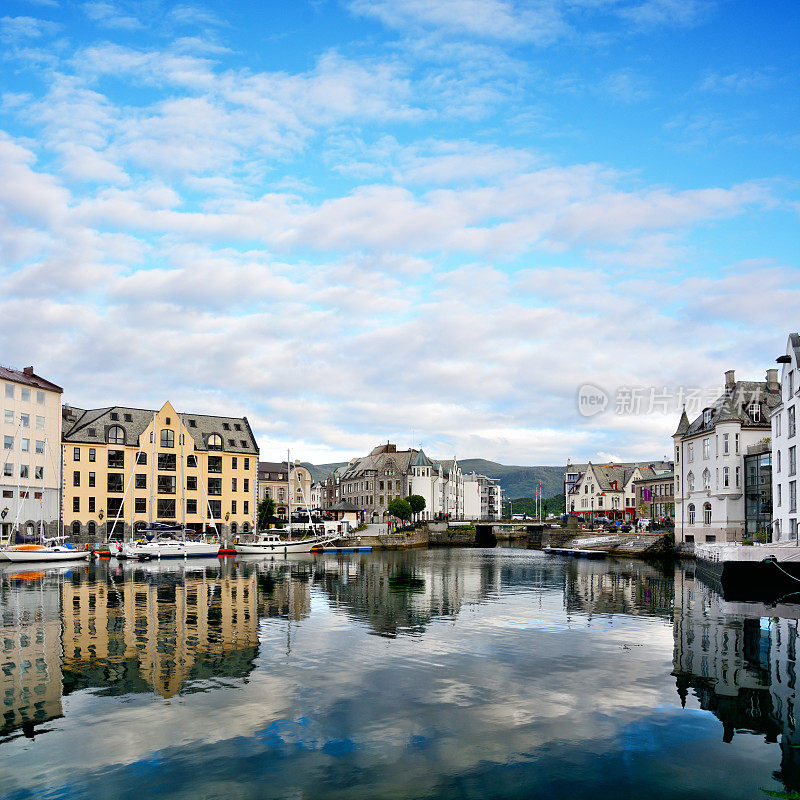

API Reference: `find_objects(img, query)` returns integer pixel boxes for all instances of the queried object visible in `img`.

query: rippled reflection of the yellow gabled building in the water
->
[62,567,258,697]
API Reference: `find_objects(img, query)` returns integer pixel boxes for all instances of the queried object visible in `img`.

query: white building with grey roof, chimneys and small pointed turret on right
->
[672,370,780,544]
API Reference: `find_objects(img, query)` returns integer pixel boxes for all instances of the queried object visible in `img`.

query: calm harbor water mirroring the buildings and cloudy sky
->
[0,548,800,800]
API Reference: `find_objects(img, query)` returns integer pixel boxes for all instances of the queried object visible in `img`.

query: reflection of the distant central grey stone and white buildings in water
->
[314,552,500,637]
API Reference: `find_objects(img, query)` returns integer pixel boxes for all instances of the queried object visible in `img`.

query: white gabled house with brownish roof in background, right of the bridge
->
[567,461,672,522]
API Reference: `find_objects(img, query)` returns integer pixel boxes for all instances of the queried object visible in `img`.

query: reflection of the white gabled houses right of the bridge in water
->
[564,561,674,618]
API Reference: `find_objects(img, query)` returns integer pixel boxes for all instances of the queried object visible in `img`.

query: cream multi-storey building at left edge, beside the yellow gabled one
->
[0,367,62,541]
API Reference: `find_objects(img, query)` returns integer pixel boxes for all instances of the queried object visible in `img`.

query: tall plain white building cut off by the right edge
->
[770,333,800,542]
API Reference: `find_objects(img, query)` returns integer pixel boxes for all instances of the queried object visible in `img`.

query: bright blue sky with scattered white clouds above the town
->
[0,0,800,464]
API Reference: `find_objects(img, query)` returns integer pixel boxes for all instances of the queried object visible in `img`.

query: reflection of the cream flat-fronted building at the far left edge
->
[0,571,62,737]
